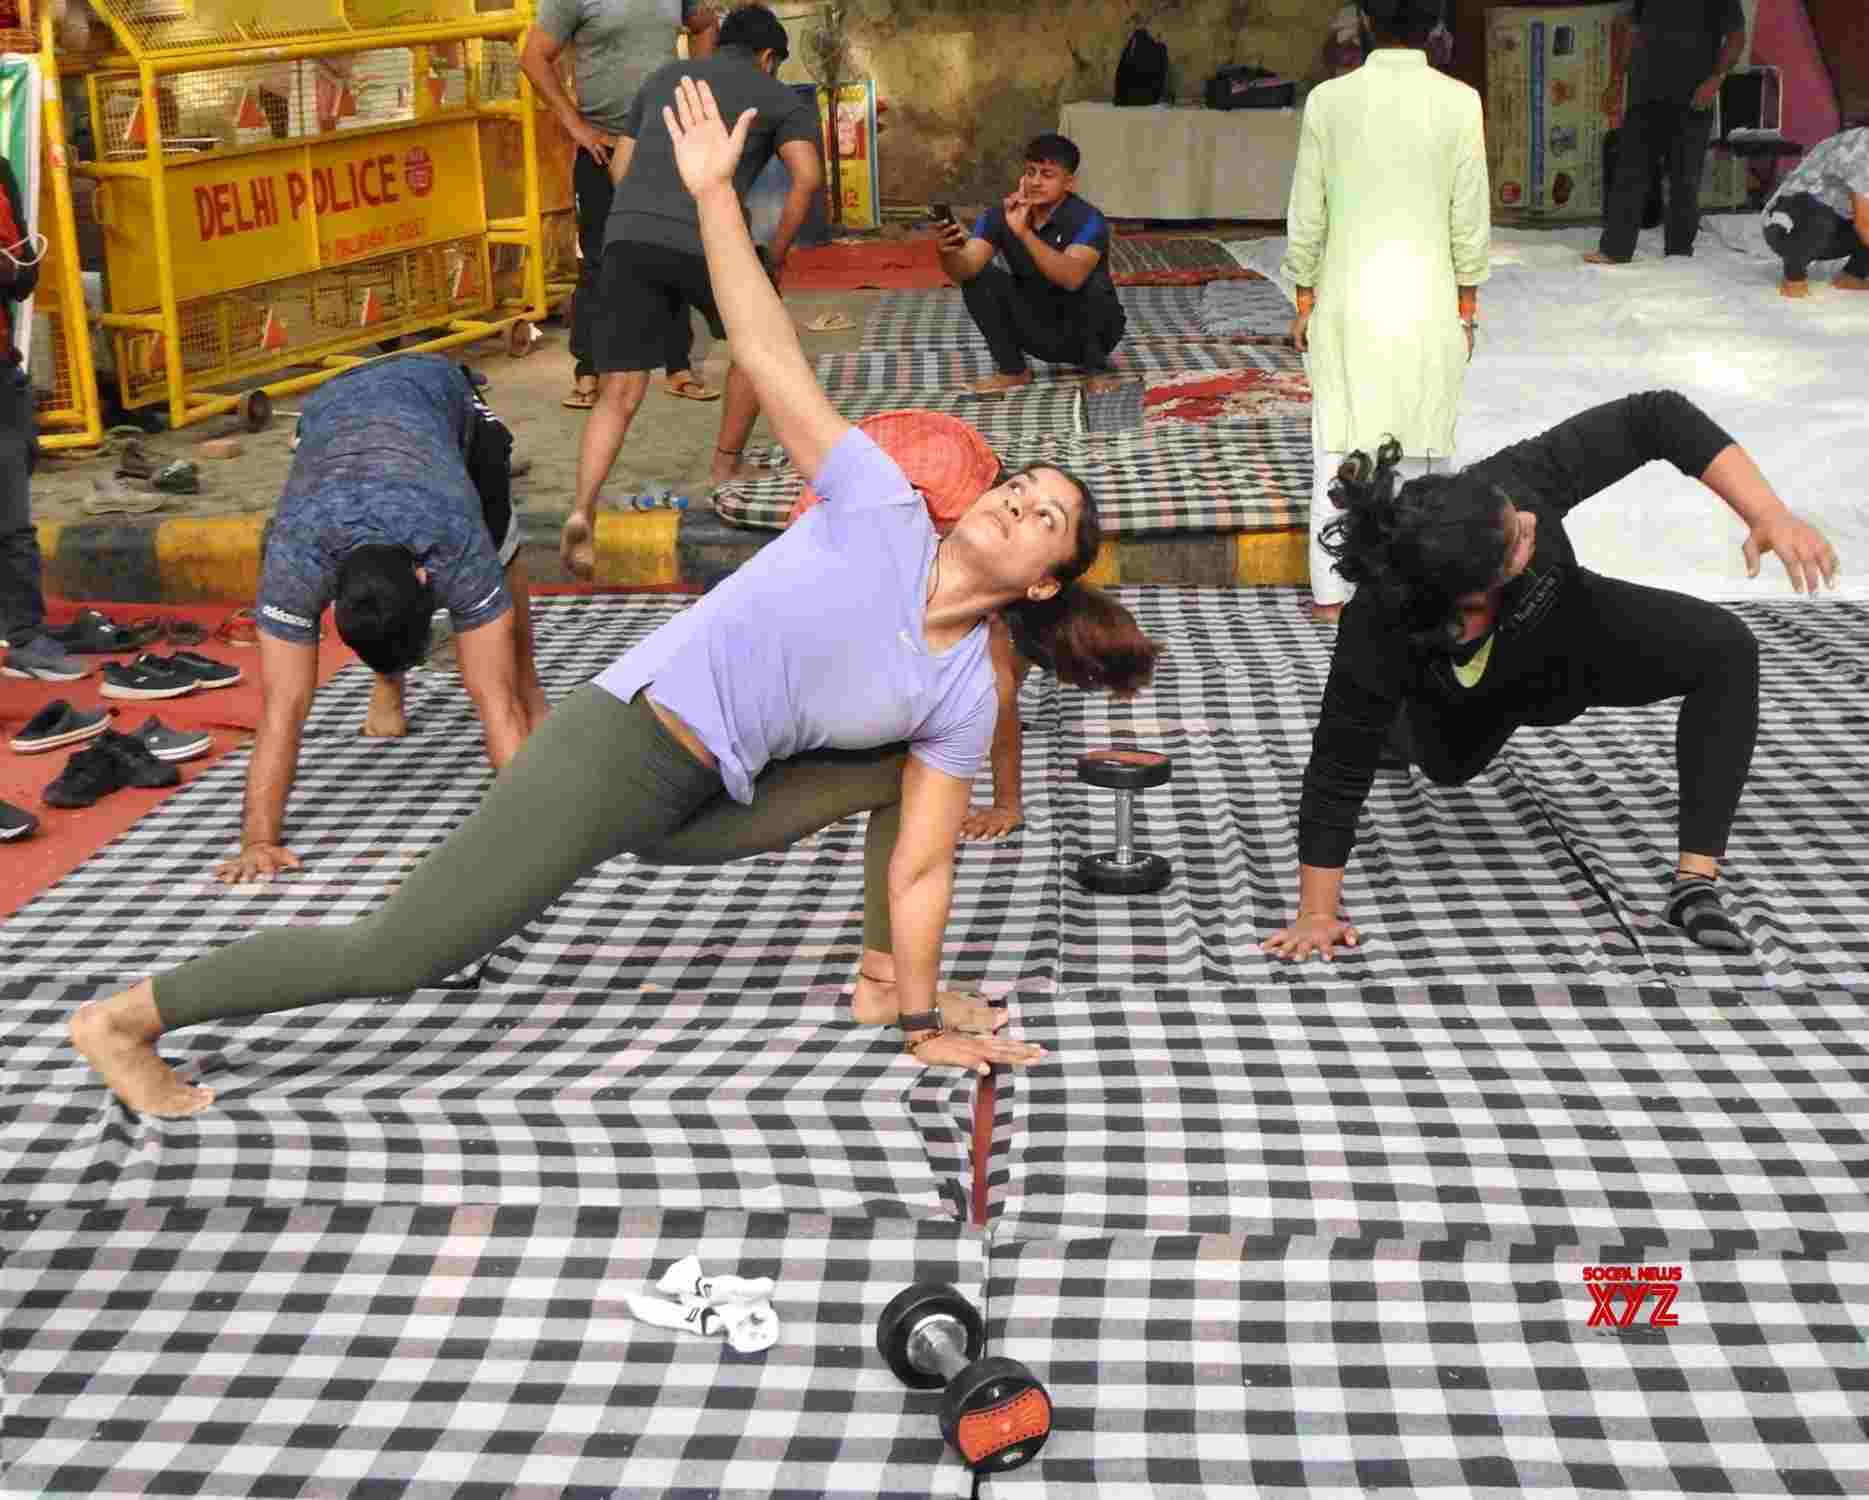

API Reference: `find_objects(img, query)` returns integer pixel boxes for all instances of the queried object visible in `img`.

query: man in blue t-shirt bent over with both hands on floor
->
[215,355,546,885]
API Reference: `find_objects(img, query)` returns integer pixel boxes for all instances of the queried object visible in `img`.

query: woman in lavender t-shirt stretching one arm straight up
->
[71,80,1155,1115]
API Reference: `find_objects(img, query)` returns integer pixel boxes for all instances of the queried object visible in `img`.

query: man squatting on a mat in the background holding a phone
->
[935,134,1127,396]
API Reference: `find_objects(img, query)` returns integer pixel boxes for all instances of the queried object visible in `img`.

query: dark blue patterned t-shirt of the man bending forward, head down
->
[256,355,512,646]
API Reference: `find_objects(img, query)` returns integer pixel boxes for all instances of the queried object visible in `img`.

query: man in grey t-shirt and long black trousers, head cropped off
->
[520,0,725,411]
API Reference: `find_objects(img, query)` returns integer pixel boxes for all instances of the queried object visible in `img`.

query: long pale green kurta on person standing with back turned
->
[1282,47,1491,458]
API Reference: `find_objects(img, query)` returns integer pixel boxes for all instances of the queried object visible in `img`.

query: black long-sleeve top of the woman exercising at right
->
[1297,390,1733,869]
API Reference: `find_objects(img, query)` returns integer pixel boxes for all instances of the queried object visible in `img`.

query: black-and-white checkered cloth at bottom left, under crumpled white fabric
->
[0,1205,985,1500]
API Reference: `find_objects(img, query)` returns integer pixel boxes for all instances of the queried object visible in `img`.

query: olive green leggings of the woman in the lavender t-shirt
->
[155,686,906,1029]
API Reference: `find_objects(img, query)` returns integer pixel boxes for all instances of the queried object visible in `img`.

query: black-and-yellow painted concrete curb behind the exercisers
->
[37,510,1310,605]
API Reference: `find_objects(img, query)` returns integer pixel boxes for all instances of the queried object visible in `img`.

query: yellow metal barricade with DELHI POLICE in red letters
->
[73,0,546,430]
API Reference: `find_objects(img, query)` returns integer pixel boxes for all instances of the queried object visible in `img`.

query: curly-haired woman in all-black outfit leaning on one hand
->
[1263,390,1837,958]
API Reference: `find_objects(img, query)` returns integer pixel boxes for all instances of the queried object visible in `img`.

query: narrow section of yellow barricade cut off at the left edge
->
[0,0,103,448]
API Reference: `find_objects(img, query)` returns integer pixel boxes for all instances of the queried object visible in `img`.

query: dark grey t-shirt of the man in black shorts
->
[604,47,819,256]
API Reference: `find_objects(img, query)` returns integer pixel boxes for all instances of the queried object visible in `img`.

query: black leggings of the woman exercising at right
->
[1405,575,1759,859]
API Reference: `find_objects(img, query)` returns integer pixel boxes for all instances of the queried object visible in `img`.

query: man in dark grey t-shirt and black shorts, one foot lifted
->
[559,6,824,579]
